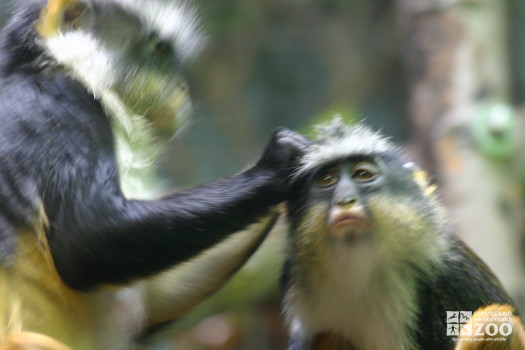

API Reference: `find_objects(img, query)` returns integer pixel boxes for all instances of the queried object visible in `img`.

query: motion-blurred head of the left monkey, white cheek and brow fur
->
[37,0,202,134]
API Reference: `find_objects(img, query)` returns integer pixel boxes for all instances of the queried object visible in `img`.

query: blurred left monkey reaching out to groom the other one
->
[0,0,312,350]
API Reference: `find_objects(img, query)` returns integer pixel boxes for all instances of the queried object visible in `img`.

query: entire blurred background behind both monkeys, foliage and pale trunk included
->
[0,0,525,350]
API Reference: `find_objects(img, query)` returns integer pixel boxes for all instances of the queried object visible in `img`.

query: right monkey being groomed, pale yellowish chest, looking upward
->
[282,120,522,350]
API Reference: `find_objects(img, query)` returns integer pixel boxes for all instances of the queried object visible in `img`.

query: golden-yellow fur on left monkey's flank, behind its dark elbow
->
[0,205,86,350]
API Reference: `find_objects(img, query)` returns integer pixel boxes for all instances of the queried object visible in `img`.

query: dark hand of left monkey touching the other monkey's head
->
[255,128,312,186]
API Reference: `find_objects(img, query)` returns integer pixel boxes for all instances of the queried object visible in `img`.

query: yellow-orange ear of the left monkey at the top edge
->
[36,0,88,38]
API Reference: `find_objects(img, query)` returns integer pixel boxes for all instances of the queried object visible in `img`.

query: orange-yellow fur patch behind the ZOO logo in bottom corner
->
[454,304,525,350]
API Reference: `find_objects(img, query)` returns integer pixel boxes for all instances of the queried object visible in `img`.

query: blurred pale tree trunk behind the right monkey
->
[398,0,525,310]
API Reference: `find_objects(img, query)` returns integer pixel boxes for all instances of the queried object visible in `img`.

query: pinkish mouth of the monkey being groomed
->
[328,210,371,241]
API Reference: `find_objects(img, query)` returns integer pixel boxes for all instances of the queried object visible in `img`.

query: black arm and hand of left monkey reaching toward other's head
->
[49,126,310,290]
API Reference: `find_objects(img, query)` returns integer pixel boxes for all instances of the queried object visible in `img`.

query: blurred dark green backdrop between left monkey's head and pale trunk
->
[166,0,409,189]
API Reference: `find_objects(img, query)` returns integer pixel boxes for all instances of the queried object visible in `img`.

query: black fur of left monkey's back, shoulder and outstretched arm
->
[0,1,300,290]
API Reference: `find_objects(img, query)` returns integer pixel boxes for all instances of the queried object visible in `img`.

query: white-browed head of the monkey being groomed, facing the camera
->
[287,123,446,270]
